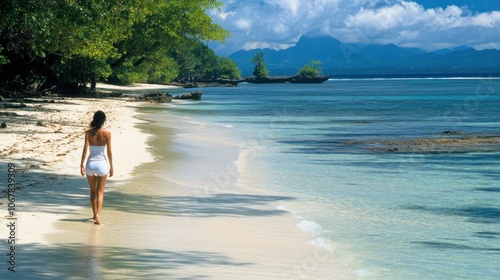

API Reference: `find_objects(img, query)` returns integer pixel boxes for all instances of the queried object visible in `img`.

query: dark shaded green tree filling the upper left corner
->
[0,0,135,90]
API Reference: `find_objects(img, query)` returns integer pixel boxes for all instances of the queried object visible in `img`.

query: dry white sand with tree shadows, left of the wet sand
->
[0,95,152,279]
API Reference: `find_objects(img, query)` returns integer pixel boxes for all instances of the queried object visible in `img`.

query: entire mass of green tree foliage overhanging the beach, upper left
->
[0,0,230,93]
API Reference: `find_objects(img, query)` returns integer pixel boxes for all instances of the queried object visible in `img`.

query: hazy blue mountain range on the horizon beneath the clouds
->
[229,36,500,77]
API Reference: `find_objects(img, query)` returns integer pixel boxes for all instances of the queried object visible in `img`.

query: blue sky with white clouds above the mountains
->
[210,0,500,55]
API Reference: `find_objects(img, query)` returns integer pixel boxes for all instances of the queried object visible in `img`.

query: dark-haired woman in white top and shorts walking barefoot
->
[80,111,113,225]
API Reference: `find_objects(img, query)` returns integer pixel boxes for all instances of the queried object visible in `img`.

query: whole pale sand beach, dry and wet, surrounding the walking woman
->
[0,85,355,279]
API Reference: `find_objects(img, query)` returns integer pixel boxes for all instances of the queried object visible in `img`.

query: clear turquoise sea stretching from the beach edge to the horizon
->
[154,78,500,279]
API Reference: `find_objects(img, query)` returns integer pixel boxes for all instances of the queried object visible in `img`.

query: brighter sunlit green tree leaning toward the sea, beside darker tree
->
[111,0,230,83]
